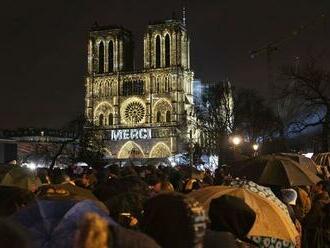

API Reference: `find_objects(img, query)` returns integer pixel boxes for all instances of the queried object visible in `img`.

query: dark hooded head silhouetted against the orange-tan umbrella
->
[209,195,256,240]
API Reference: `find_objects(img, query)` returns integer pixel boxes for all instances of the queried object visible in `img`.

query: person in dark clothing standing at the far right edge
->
[302,181,330,248]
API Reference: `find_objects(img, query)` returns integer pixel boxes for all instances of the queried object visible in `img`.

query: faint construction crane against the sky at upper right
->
[250,13,326,90]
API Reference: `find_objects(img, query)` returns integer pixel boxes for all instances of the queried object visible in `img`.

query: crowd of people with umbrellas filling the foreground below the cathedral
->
[0,161,330,248]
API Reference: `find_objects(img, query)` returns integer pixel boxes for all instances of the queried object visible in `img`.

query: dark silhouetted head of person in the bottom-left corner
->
[0,219,32,248]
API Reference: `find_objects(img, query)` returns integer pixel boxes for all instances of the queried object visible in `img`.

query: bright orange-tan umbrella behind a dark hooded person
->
[189,186,298,243]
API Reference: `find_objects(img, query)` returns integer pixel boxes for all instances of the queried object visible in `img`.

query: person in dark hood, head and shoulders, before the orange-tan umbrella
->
[204,195,257,248]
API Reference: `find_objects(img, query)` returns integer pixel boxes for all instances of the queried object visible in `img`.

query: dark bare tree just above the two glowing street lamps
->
[234,89,281,143]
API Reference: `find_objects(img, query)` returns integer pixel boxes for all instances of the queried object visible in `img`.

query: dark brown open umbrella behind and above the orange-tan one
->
[230,155,321,187]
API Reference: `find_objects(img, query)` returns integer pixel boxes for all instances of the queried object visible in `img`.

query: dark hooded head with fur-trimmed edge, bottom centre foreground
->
[141,193,207,248]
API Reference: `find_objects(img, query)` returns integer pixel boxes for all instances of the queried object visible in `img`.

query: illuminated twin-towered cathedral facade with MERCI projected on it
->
[85,20,194,159]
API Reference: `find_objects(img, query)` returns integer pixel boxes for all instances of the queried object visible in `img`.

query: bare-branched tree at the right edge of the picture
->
[279,57,330,152]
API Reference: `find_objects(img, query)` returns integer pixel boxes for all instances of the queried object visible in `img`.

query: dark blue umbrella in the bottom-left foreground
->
[11,200,116,248]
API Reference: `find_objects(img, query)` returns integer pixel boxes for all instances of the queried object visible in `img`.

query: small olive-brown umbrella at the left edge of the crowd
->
[0,166,41,191]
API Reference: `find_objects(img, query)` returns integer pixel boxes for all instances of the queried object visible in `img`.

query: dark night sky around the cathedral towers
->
[0,0,330,128]
